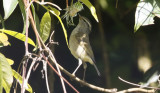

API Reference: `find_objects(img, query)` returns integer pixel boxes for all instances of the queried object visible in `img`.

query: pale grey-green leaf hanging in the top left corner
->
[3,0,18,19]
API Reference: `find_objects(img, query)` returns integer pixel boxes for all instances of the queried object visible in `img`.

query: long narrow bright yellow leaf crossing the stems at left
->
[0,29,35,46]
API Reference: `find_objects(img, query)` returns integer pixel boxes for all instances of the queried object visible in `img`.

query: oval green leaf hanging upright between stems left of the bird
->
[40,12,51,43]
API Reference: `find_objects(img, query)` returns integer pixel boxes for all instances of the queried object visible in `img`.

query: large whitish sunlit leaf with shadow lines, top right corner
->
[134,0,160,32]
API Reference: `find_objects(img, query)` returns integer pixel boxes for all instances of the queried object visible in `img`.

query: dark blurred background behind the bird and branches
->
[0,0,160,93]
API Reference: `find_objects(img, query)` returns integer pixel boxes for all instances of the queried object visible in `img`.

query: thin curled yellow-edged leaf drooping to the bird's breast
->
[50,8,68,46]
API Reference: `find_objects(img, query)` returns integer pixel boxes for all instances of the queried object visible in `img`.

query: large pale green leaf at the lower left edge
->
[0,53,13,93]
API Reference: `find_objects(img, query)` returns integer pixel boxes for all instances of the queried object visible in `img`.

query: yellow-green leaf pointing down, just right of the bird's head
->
[80,0,99,22]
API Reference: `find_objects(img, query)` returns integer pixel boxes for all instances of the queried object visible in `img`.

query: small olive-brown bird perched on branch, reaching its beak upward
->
[69,15,100,80]
